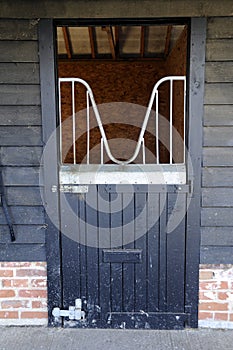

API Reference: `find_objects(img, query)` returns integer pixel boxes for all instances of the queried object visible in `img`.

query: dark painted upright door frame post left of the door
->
[39,19,62,326]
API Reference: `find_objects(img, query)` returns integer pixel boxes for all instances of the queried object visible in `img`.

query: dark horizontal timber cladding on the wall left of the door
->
[0,20,45,261]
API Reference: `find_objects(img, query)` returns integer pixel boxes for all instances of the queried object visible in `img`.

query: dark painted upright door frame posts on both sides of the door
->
[39,18,206,328]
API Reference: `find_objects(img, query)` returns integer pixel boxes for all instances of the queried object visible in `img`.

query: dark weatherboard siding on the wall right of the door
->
[201,17,233,264]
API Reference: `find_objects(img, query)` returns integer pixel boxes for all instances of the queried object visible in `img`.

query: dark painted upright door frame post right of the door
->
[185,18,206,328]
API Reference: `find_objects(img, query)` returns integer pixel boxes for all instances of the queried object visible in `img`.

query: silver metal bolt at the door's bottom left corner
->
[52,299,85,321]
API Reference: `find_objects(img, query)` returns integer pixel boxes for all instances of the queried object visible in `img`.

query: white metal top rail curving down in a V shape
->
[59,76,185,164]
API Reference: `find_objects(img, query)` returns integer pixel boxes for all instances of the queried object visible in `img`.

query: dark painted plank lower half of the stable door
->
[60,185,190,328]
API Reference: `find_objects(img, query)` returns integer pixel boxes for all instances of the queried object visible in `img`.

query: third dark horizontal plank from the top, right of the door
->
[205,62,233,83]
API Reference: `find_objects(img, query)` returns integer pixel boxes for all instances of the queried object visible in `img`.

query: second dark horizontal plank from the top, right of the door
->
[206,39,233,61]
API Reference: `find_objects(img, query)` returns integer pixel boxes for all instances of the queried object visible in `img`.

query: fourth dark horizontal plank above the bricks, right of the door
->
[202,189,233,207]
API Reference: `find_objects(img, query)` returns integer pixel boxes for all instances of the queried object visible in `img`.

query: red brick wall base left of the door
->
[0,262,47,325]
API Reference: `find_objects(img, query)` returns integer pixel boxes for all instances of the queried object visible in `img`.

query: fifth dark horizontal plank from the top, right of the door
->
[204,105,233,126]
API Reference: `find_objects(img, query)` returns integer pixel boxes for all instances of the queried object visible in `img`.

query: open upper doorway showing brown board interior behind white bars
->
[57,23,188,183]
